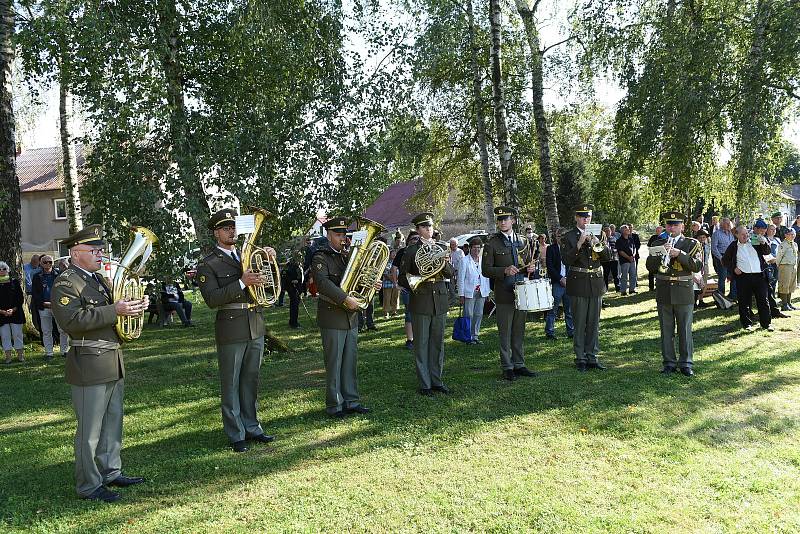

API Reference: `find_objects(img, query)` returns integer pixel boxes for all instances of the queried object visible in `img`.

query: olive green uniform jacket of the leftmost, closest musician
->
[50,266,125,386]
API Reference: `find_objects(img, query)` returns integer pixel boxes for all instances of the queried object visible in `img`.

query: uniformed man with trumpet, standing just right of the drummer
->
[561,204,611,372]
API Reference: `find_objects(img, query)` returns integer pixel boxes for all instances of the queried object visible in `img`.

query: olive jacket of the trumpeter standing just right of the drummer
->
[561,228,611,298]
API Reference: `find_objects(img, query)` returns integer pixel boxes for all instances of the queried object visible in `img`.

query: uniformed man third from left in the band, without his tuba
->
[311,217,378,418]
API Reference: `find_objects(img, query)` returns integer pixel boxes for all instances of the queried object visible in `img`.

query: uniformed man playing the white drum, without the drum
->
[481,206,538,381]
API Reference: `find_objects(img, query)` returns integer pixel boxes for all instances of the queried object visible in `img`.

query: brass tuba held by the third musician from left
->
[339,217,389,310]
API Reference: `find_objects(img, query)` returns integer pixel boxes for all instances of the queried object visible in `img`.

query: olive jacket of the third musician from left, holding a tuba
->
[311,246,358,330]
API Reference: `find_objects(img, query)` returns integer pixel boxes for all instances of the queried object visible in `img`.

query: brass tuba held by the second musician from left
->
[242,206,281,307]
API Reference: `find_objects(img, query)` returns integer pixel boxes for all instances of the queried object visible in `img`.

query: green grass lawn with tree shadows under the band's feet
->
[0,280,800,533]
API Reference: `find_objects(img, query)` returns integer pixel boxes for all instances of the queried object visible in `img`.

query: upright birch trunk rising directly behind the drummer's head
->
[489,0,519,209]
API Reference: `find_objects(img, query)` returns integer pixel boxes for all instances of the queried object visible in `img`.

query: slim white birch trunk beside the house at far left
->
[58,64,83,234]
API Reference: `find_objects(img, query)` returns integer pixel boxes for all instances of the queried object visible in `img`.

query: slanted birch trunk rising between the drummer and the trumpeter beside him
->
[516,0,561,236]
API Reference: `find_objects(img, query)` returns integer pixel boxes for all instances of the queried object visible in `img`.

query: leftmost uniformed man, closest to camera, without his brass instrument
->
[50,224,149,502]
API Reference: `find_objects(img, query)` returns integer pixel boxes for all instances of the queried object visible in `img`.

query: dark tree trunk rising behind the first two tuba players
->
[158,0,210,244]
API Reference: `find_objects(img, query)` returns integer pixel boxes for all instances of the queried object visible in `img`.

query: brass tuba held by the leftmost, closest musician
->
[111,226,158,342]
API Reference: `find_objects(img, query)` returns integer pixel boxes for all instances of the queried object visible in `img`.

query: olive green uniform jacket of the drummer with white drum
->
[481,232,539,304]
